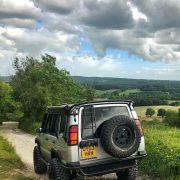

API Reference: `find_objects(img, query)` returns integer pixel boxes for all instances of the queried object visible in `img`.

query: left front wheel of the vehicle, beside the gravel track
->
[33,146,47,174]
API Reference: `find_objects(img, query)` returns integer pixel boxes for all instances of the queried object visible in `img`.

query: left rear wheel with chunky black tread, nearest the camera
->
[49,158,72,180]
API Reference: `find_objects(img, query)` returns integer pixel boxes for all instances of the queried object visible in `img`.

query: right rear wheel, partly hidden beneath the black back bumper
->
[116,166,138,180]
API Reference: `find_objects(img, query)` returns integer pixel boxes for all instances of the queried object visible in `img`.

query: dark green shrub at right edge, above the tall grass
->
[163,109,180,127]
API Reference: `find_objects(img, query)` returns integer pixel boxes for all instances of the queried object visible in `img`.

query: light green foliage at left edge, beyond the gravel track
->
[0,82,23,122]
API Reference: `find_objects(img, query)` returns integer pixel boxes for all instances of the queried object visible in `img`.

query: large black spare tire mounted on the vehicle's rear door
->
[100,116,141,158]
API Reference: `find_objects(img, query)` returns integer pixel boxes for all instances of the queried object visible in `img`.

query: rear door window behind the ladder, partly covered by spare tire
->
[81,106,129,140]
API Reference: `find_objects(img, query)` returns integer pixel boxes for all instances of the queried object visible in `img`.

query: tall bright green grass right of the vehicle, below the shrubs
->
[140,121,180,180]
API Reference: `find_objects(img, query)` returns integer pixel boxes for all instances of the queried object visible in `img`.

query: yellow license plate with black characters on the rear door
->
[81,146,96,159]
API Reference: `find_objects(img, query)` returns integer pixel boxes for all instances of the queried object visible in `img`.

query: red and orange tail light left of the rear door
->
[69,125,78,146]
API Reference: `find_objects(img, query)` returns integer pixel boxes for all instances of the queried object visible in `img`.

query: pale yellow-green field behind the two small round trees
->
[135,105,180,119]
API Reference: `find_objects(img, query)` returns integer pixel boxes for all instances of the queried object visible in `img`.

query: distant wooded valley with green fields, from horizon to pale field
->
[73,76,180,106]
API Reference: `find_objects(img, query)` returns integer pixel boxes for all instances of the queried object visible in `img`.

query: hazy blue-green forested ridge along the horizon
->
[73,76,180,93]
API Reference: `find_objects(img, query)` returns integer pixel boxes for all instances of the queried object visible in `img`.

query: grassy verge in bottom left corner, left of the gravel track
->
[0,136,33,180]
